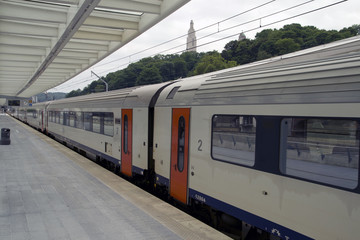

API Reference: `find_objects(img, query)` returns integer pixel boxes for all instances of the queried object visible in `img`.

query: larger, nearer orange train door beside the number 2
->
[170,108,190,204]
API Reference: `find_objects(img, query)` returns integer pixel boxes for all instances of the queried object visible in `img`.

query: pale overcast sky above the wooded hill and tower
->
[49,0,360,92]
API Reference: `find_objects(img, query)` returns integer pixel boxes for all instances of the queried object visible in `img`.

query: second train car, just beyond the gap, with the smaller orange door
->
[47,83,168,177]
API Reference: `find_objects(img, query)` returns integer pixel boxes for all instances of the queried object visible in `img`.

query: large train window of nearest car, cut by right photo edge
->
[280,118,360,189]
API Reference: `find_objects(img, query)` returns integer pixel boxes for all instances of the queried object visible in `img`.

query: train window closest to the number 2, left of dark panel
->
[211,115,256,166]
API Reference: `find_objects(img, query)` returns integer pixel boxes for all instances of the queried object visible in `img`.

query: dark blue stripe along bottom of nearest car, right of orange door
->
[189,188,313,240]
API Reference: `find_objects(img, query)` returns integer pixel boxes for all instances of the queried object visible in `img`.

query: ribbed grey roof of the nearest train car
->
[157,36,360,106]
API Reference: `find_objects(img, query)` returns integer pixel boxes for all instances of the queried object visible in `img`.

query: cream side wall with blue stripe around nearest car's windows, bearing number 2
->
[189,104,360,239]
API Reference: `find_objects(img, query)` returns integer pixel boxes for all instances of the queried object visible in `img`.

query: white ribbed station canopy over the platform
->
[0,0,189,98]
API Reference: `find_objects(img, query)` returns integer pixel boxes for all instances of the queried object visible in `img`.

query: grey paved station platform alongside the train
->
[0,114,229,240]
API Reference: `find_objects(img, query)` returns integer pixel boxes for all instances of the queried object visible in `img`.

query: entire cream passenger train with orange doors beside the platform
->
[12,36,360,240]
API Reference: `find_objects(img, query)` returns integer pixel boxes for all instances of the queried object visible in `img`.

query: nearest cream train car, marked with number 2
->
[154,37,360,239]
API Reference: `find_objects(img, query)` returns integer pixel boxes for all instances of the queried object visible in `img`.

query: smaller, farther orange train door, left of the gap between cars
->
[121,109,132,176]
